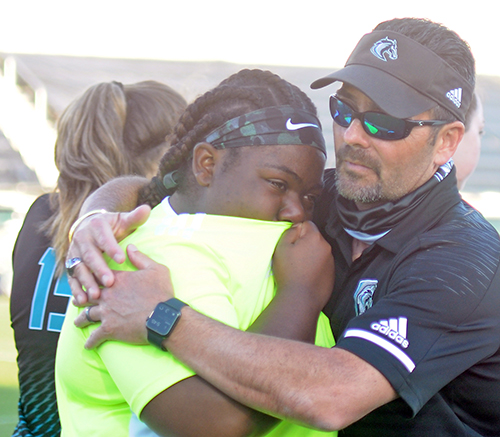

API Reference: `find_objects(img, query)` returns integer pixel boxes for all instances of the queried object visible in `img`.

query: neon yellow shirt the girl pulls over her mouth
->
[56,200,334,437]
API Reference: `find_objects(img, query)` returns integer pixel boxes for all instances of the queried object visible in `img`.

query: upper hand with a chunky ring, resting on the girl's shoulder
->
[66,205,151,306]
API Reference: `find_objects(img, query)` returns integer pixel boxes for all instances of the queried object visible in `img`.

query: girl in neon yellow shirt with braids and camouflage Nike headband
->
[56,70,333,437]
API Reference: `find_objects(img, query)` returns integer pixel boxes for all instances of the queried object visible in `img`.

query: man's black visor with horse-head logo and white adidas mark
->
[311,30,473,122]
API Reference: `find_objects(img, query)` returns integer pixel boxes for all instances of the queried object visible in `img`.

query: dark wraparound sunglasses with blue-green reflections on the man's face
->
[330,96,450,141]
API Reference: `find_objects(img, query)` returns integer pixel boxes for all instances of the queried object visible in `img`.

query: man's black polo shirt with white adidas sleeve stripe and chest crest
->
[317,170,500,437]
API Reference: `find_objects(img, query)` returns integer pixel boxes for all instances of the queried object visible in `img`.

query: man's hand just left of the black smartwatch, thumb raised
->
[75,245,173,349]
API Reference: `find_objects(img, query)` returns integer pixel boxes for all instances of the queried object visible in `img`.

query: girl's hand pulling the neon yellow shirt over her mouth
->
[273,222,335,310]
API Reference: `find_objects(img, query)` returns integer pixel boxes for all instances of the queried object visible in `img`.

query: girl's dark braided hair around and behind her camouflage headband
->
[138,69,316,207]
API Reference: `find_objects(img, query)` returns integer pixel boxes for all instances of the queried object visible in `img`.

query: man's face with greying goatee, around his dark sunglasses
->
[333,84,439,209]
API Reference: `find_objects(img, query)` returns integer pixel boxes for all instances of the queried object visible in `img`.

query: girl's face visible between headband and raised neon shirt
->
[205,145,325,223]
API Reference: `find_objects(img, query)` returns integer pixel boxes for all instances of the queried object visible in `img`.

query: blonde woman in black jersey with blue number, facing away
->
[11,81,187,437]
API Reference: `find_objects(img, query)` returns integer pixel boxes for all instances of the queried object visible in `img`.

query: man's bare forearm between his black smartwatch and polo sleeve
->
[164,307,397,430]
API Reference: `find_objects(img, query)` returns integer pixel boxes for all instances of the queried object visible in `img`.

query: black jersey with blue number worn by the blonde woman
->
[10,195,71,437]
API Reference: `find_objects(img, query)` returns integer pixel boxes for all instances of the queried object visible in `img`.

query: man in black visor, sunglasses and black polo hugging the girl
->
[67,19,500,436]
